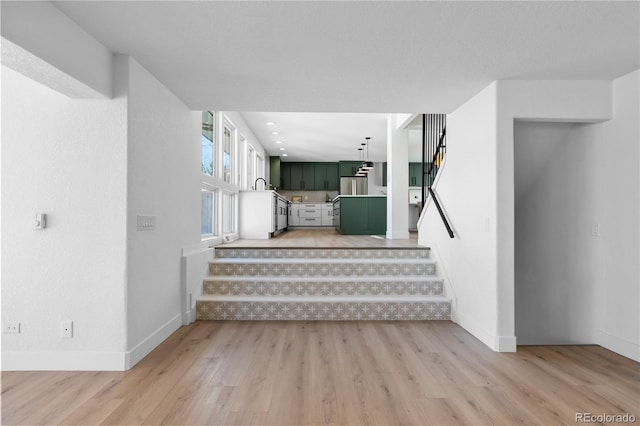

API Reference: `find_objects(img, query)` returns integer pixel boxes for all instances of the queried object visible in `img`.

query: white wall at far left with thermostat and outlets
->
[2,67,127,370]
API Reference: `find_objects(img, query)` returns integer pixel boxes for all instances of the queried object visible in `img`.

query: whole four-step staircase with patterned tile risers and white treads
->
[196,247,451,320]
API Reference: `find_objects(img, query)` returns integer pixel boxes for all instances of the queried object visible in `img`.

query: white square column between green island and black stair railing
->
[387,114,409,239]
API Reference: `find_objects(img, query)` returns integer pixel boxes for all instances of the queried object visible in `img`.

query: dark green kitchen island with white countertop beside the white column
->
[333,195,387,235]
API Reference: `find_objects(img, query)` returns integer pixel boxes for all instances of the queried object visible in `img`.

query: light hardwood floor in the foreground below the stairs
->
[2,321,640,425]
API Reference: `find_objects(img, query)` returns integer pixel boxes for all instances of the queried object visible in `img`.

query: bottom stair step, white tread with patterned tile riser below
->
[196,295,451,321]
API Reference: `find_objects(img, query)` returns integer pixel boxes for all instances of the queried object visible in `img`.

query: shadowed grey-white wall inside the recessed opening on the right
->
[514,122,603,345]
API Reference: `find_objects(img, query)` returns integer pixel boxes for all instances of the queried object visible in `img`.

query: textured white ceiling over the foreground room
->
[54,1,640,161]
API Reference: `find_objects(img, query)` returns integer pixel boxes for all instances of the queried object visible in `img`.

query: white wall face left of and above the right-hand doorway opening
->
[496,80,611,349]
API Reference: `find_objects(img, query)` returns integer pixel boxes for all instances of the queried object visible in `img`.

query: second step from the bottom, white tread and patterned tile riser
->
[203,276,443,296]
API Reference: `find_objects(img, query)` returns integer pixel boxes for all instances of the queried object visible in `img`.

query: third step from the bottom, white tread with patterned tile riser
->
[209,259,436,277]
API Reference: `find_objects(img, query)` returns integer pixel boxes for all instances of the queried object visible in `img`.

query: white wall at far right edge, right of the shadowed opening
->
[589,70,640,362]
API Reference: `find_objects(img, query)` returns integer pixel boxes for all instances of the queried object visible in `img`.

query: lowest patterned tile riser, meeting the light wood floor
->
[196,301,451,321]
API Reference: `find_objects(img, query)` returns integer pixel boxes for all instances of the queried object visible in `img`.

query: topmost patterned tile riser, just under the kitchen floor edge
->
[215,248,429,259]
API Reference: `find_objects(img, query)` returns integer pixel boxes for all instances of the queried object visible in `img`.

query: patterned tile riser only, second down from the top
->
[209,263,436,277]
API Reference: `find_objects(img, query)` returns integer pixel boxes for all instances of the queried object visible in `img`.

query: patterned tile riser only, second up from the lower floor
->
[204,281,442,296]
